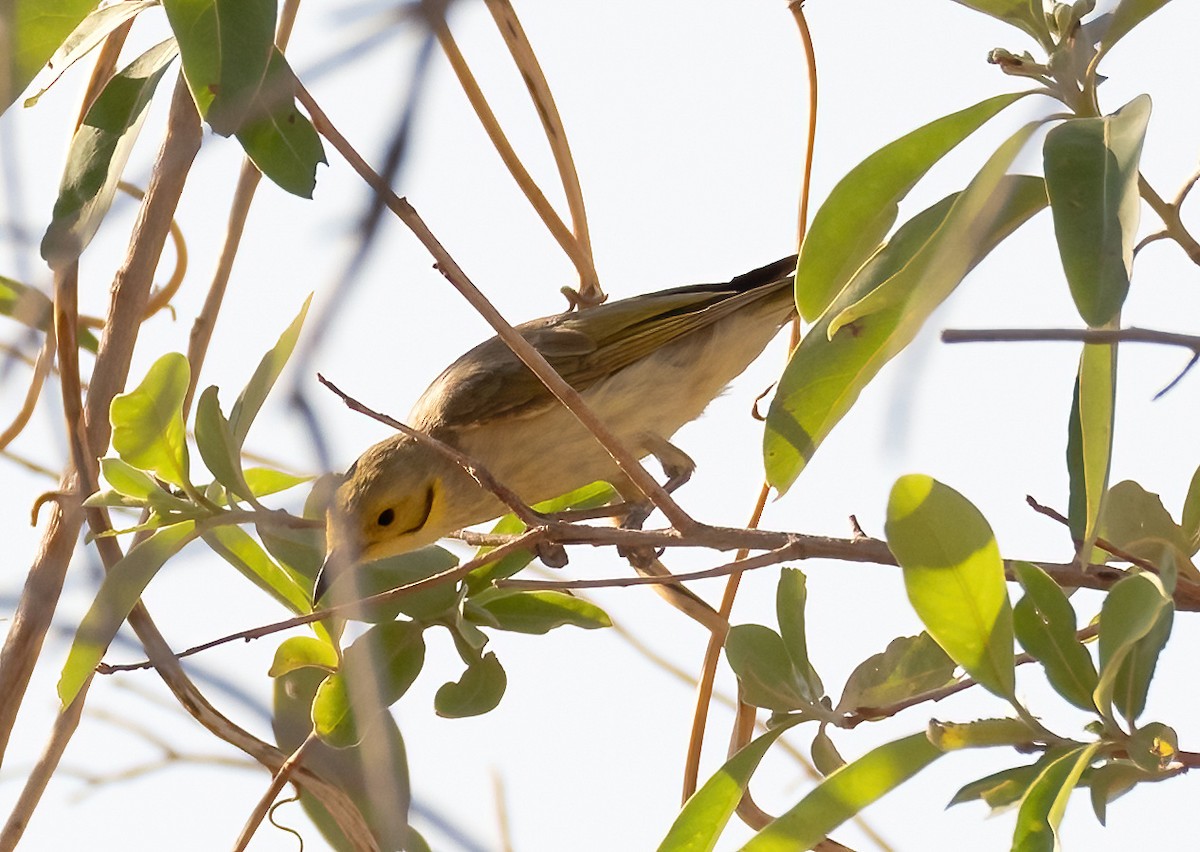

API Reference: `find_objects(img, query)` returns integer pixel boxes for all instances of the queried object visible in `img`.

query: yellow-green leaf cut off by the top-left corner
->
[0,0,96,113]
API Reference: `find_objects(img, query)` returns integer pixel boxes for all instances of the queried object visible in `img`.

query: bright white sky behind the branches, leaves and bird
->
[0,0,1200,852]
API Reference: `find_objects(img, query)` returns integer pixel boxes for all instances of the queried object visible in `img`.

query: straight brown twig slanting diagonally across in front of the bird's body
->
[296,80,697,530]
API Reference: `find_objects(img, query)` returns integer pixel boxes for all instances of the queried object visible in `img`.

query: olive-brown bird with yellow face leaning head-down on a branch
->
[313,256,796,606]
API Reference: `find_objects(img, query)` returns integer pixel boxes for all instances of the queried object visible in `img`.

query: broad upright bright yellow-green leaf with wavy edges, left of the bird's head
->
[109,352,192,486]
